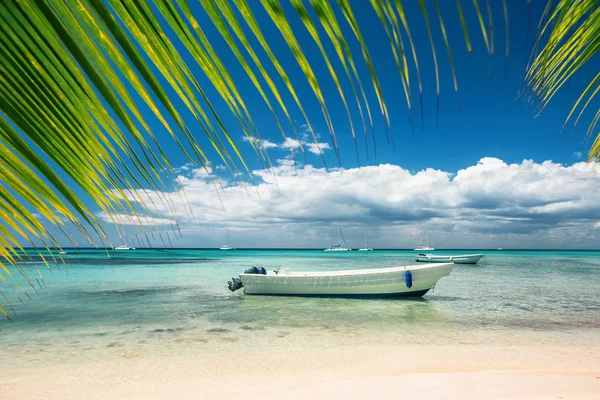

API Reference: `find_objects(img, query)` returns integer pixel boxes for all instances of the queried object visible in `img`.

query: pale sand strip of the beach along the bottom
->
[0,344,600,400]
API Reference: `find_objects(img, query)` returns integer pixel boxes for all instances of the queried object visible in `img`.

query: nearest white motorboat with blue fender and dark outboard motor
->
[229,263,454,297]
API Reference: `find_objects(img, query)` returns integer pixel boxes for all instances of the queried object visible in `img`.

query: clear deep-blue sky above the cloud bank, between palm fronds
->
[162,1,596,170]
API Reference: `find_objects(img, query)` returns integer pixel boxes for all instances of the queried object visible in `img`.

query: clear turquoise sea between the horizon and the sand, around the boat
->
[0,249,600,367]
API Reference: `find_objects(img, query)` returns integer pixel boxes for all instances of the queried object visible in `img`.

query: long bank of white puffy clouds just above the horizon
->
[106,158,600,248]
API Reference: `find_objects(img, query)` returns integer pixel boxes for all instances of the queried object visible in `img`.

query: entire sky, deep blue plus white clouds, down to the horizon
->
[34,1,600,248]
